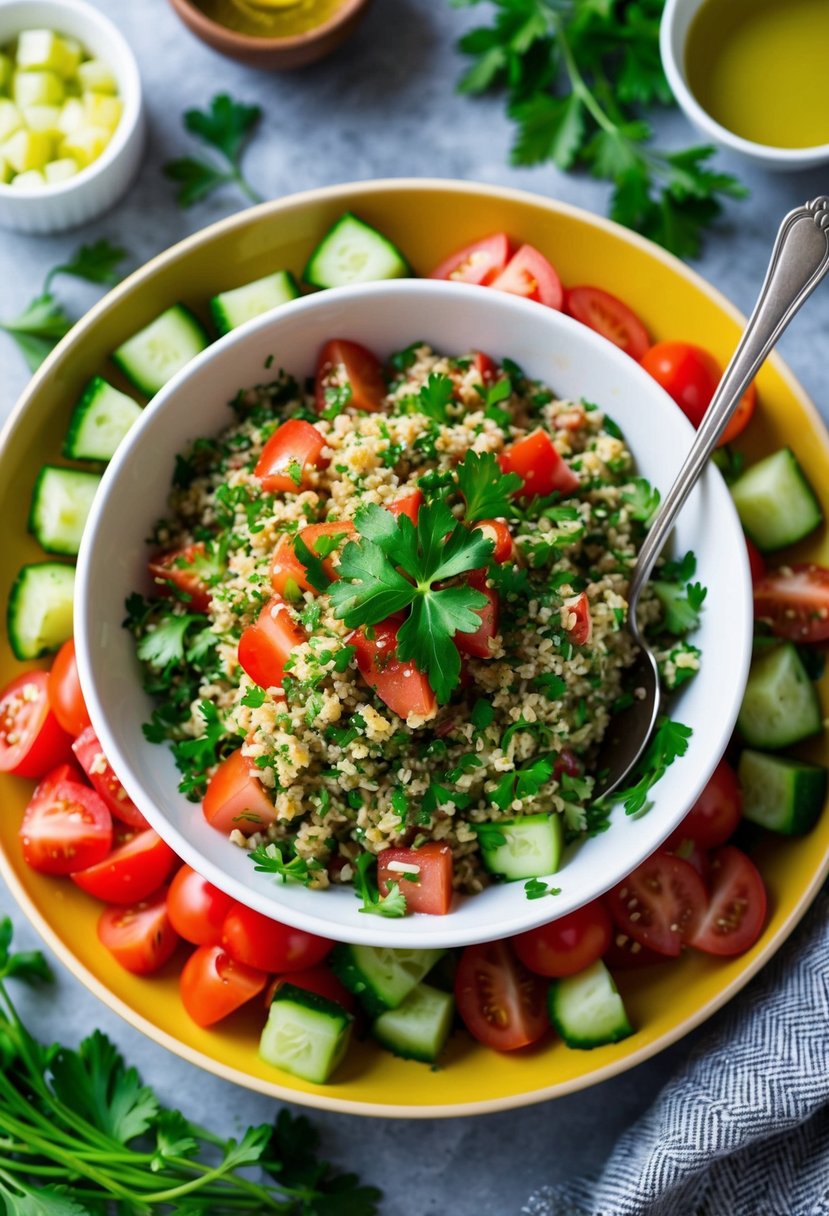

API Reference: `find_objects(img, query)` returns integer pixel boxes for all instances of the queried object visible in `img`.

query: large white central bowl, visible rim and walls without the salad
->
[75,280,751,947]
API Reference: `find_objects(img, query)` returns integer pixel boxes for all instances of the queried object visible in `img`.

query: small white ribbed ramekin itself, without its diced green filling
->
[0,0,145,232]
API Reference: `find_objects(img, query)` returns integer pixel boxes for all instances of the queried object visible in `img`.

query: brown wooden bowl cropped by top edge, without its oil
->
[170,0,371,72]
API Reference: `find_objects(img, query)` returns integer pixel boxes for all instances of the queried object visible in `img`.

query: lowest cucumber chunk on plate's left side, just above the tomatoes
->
[6,562,75,659]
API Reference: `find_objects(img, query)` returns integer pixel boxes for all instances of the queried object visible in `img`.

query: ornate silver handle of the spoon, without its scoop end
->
[628,195,829,608]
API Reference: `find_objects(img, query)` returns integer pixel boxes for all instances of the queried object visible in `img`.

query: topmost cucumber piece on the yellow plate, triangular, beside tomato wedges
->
[303,212,412,287]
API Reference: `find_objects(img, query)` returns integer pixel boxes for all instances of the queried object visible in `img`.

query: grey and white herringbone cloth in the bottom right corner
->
[521,891,829,1216]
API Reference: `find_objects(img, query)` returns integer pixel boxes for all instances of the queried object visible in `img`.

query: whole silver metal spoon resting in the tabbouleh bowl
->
[596,195,829,798]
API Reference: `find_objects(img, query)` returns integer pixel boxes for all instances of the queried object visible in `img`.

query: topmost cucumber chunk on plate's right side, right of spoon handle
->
[731,447,823,553]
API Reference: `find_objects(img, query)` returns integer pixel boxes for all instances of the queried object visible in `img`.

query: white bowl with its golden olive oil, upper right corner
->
[660,0,829,170]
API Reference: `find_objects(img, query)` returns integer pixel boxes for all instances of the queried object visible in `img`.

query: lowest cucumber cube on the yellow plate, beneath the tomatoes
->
[259,984,354,1085]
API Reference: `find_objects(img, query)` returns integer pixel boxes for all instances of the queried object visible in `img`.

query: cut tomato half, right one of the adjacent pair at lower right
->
[688,845,766,957]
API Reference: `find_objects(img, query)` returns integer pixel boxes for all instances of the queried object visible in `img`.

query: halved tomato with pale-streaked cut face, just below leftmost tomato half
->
[18,765,112,874]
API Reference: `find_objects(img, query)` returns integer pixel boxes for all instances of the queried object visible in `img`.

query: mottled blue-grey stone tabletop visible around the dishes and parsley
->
[0,0,829,1216]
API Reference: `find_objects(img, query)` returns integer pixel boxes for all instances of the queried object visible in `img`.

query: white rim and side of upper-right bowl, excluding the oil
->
[659,0,829,171]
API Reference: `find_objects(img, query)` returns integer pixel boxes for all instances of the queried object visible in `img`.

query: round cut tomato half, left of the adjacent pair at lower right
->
[607,850,707,958]
